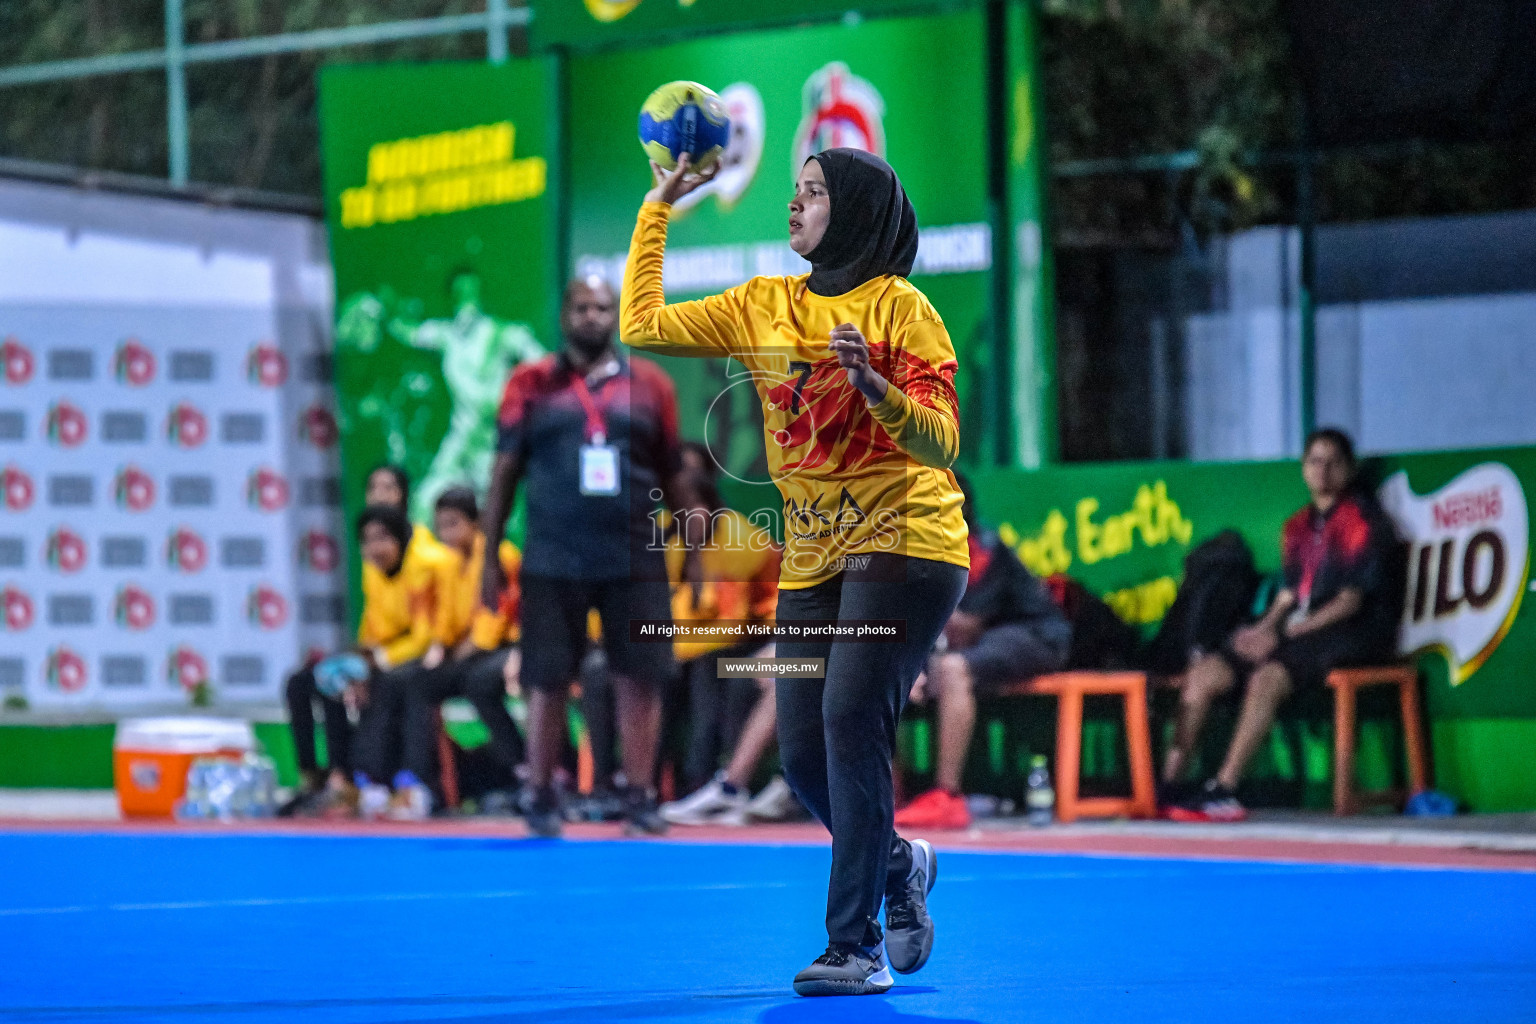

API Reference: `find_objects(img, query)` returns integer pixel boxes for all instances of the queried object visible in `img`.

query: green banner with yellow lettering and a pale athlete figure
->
[319,58,559,601]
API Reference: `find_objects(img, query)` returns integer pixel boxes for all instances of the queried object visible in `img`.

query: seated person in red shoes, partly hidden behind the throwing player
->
[895,473,1072,829]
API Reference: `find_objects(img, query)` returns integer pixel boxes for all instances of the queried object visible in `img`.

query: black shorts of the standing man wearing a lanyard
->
[521,573,674,691]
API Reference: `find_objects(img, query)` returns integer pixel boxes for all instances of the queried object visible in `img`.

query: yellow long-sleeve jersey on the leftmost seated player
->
[358,537,461,668]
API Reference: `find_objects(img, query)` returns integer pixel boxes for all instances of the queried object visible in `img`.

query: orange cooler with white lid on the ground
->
[112,717,257,818]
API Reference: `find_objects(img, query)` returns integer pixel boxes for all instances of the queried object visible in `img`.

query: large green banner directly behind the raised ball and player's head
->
[568,12,992,491]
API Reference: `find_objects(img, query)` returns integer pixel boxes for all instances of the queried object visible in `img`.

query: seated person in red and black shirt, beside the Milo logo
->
[1163,428,1398,821]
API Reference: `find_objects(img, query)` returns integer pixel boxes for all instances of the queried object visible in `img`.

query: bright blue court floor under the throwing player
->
[0,832,1536,1024]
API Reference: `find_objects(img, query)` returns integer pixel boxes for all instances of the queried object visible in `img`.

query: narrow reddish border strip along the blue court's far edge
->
[0,818,1536,872]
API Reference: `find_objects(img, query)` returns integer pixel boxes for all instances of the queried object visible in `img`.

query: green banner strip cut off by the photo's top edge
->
[530,0,960,49]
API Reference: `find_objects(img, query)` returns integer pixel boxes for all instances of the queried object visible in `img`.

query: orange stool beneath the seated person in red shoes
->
[998,671,1157,823]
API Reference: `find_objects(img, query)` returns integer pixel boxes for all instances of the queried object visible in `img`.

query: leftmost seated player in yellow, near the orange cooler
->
[342,505,456,817]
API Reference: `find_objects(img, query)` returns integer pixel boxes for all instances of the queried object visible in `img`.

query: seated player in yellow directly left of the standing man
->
[393,487,524,820]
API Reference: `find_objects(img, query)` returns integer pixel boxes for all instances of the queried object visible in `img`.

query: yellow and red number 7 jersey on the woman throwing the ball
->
[619,203,969,590]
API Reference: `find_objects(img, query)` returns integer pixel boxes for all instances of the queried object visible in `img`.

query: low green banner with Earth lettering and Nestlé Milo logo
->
[977,448,1536,809]
